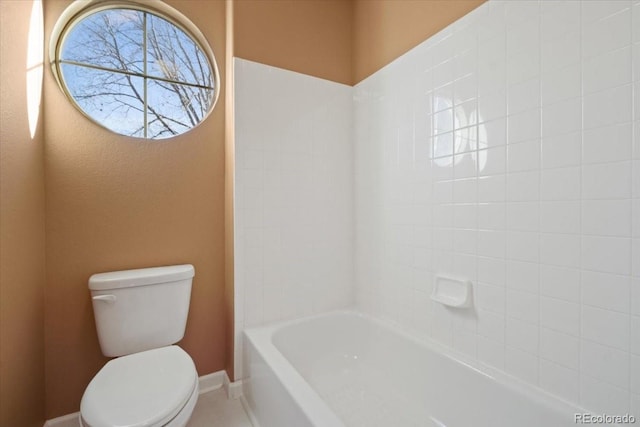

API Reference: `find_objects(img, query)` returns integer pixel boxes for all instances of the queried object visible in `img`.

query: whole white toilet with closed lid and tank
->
[79,264,198,427]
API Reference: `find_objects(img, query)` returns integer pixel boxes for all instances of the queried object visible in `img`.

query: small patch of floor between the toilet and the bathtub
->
[187,388,252,427]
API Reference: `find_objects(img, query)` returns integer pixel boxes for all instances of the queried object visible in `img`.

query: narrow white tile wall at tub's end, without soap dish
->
[234,58,354,378]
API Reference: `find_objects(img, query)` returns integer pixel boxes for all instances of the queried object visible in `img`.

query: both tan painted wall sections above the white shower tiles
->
[234,0,485,85]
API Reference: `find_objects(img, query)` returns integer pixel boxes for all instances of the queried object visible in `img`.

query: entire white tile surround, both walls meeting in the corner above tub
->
[235,0,640,415]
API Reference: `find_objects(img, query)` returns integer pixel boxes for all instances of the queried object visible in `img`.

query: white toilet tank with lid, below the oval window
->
[89,264,195,357]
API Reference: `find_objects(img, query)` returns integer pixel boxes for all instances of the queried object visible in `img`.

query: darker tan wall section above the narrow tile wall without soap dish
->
[234,0,352,84]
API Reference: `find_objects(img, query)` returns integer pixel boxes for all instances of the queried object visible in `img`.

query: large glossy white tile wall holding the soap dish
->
[353,0,640,415]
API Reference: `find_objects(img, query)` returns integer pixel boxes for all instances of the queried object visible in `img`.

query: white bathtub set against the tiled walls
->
[243,312,585,427]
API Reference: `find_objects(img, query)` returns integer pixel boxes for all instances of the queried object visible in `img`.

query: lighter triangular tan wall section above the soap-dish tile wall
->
[352,0,485,84]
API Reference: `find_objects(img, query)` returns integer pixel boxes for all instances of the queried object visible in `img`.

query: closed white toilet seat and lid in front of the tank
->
[80,345,198,427]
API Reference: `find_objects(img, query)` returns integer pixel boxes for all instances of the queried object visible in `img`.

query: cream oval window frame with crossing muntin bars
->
[49,0,221,141]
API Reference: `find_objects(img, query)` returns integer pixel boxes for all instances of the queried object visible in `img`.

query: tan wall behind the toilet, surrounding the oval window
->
[44,0,226,418]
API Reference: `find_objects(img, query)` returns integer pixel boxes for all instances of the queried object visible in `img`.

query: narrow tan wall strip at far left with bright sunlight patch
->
[0,1,45,427]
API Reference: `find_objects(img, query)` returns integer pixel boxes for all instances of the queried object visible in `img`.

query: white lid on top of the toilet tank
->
[89,264,195,291]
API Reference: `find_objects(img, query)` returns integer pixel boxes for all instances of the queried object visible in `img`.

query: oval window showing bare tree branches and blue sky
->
[53,4,218,139]
